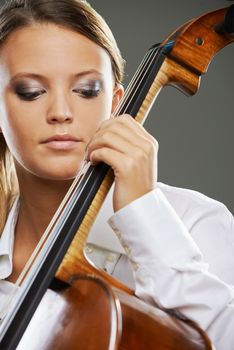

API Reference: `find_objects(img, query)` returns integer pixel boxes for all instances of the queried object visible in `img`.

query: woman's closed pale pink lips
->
[41,134,81,150]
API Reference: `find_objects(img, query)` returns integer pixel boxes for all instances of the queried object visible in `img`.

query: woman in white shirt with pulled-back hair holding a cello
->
[0,0,234,349]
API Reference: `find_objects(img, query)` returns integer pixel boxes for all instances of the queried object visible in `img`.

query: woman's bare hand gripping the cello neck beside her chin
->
[87,114,158,211]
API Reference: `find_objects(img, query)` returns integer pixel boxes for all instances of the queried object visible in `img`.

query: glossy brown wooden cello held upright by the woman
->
[0,6,234,349]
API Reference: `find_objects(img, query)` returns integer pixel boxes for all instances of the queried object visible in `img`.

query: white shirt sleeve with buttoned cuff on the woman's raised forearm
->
[109,188,234,350]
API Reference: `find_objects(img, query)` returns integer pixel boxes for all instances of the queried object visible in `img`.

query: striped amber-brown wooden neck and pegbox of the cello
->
[57,8,234,293]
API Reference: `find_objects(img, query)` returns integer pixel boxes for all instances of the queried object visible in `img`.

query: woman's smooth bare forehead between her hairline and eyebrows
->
[0,24,111,74]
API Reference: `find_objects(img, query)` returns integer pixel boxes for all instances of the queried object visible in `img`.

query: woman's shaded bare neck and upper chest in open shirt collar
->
[9,166,72,282]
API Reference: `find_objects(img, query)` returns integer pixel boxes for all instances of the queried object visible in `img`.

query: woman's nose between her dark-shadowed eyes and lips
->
[47,93,73,124]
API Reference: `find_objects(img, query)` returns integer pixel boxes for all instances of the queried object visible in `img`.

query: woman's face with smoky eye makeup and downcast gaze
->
[0,24,120,180]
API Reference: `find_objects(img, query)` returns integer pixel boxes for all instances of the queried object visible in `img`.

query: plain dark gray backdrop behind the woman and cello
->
[90,0,234,213]
